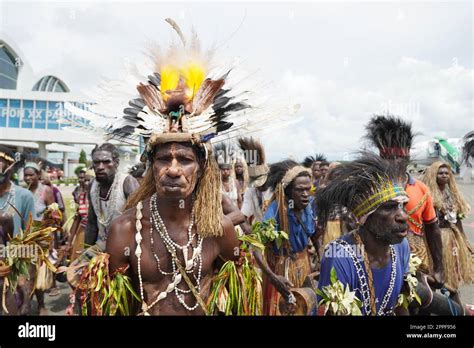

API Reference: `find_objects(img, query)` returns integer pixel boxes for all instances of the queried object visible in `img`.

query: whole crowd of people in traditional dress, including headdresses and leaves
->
[0,20,474,316]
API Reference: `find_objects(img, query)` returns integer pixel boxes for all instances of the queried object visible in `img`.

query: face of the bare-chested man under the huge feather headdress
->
[153,143,201,199]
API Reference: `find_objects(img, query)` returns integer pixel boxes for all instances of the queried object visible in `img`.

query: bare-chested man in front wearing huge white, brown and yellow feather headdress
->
[107,19,256,315]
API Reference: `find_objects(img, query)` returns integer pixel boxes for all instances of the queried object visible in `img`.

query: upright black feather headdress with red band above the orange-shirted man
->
[365,115,414,159]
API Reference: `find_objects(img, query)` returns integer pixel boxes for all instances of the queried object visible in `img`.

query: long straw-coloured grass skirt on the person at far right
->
[441,224,474,289]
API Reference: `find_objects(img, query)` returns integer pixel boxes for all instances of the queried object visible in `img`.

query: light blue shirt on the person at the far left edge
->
[0,183,35,236]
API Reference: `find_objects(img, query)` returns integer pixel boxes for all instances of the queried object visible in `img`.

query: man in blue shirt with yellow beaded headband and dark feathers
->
[316,155,410,315]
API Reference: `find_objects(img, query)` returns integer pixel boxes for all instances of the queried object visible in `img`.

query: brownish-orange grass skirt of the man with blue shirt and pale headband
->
[263,249,311,315]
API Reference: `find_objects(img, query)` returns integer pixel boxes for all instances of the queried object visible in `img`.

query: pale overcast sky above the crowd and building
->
[0,0,474,161]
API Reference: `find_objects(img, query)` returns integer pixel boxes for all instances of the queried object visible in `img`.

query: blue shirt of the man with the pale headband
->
[263,197,314,255]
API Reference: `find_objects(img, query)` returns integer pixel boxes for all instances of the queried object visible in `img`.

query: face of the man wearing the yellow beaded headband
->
[364,201,408,244]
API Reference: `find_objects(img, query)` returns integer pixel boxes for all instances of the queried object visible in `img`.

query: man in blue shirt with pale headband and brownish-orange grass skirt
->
[255,160,314,315]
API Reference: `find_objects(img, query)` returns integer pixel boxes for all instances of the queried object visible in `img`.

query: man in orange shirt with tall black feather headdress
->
[366,115,443,286]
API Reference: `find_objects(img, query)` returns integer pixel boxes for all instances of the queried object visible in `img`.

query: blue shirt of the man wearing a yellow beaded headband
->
[318,235,410,315]
